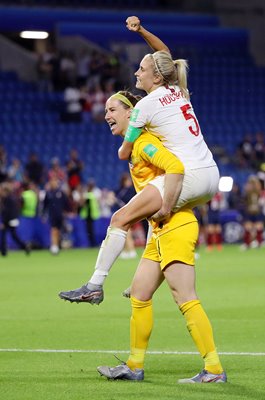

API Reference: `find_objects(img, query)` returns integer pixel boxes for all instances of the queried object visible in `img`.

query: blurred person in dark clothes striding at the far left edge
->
[0,182,30,256]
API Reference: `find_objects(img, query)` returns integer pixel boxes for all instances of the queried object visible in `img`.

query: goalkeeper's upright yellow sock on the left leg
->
[126,297,153,370]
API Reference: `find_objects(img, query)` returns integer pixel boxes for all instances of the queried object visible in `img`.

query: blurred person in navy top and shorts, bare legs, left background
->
[43,177,70,255]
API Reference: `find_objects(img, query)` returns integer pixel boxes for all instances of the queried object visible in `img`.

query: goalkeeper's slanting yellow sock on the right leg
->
[179,300,223,374]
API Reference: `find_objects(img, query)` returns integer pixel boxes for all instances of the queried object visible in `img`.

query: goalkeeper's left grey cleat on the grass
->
[97,363,144,381]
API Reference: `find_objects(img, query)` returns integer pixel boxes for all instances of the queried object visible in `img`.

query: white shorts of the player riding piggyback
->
[149,166,220,211]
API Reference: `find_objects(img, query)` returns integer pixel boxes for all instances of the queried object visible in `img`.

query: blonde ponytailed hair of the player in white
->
[149,50,190,99]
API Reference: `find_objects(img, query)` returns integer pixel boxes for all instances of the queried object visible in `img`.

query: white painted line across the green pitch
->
[0,349,265,357]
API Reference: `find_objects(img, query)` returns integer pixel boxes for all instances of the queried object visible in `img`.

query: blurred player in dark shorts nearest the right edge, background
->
[241,175,264,250]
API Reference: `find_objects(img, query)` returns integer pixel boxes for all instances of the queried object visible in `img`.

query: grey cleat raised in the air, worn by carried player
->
[59,284,104,304]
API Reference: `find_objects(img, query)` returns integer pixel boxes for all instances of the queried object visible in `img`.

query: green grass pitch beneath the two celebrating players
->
[0,246,265,400]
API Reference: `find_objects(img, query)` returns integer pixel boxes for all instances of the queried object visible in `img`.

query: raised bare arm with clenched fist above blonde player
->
[126,16,170,53]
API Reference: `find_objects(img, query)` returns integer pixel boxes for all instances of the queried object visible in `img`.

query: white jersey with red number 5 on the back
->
[130,86,216,169]
